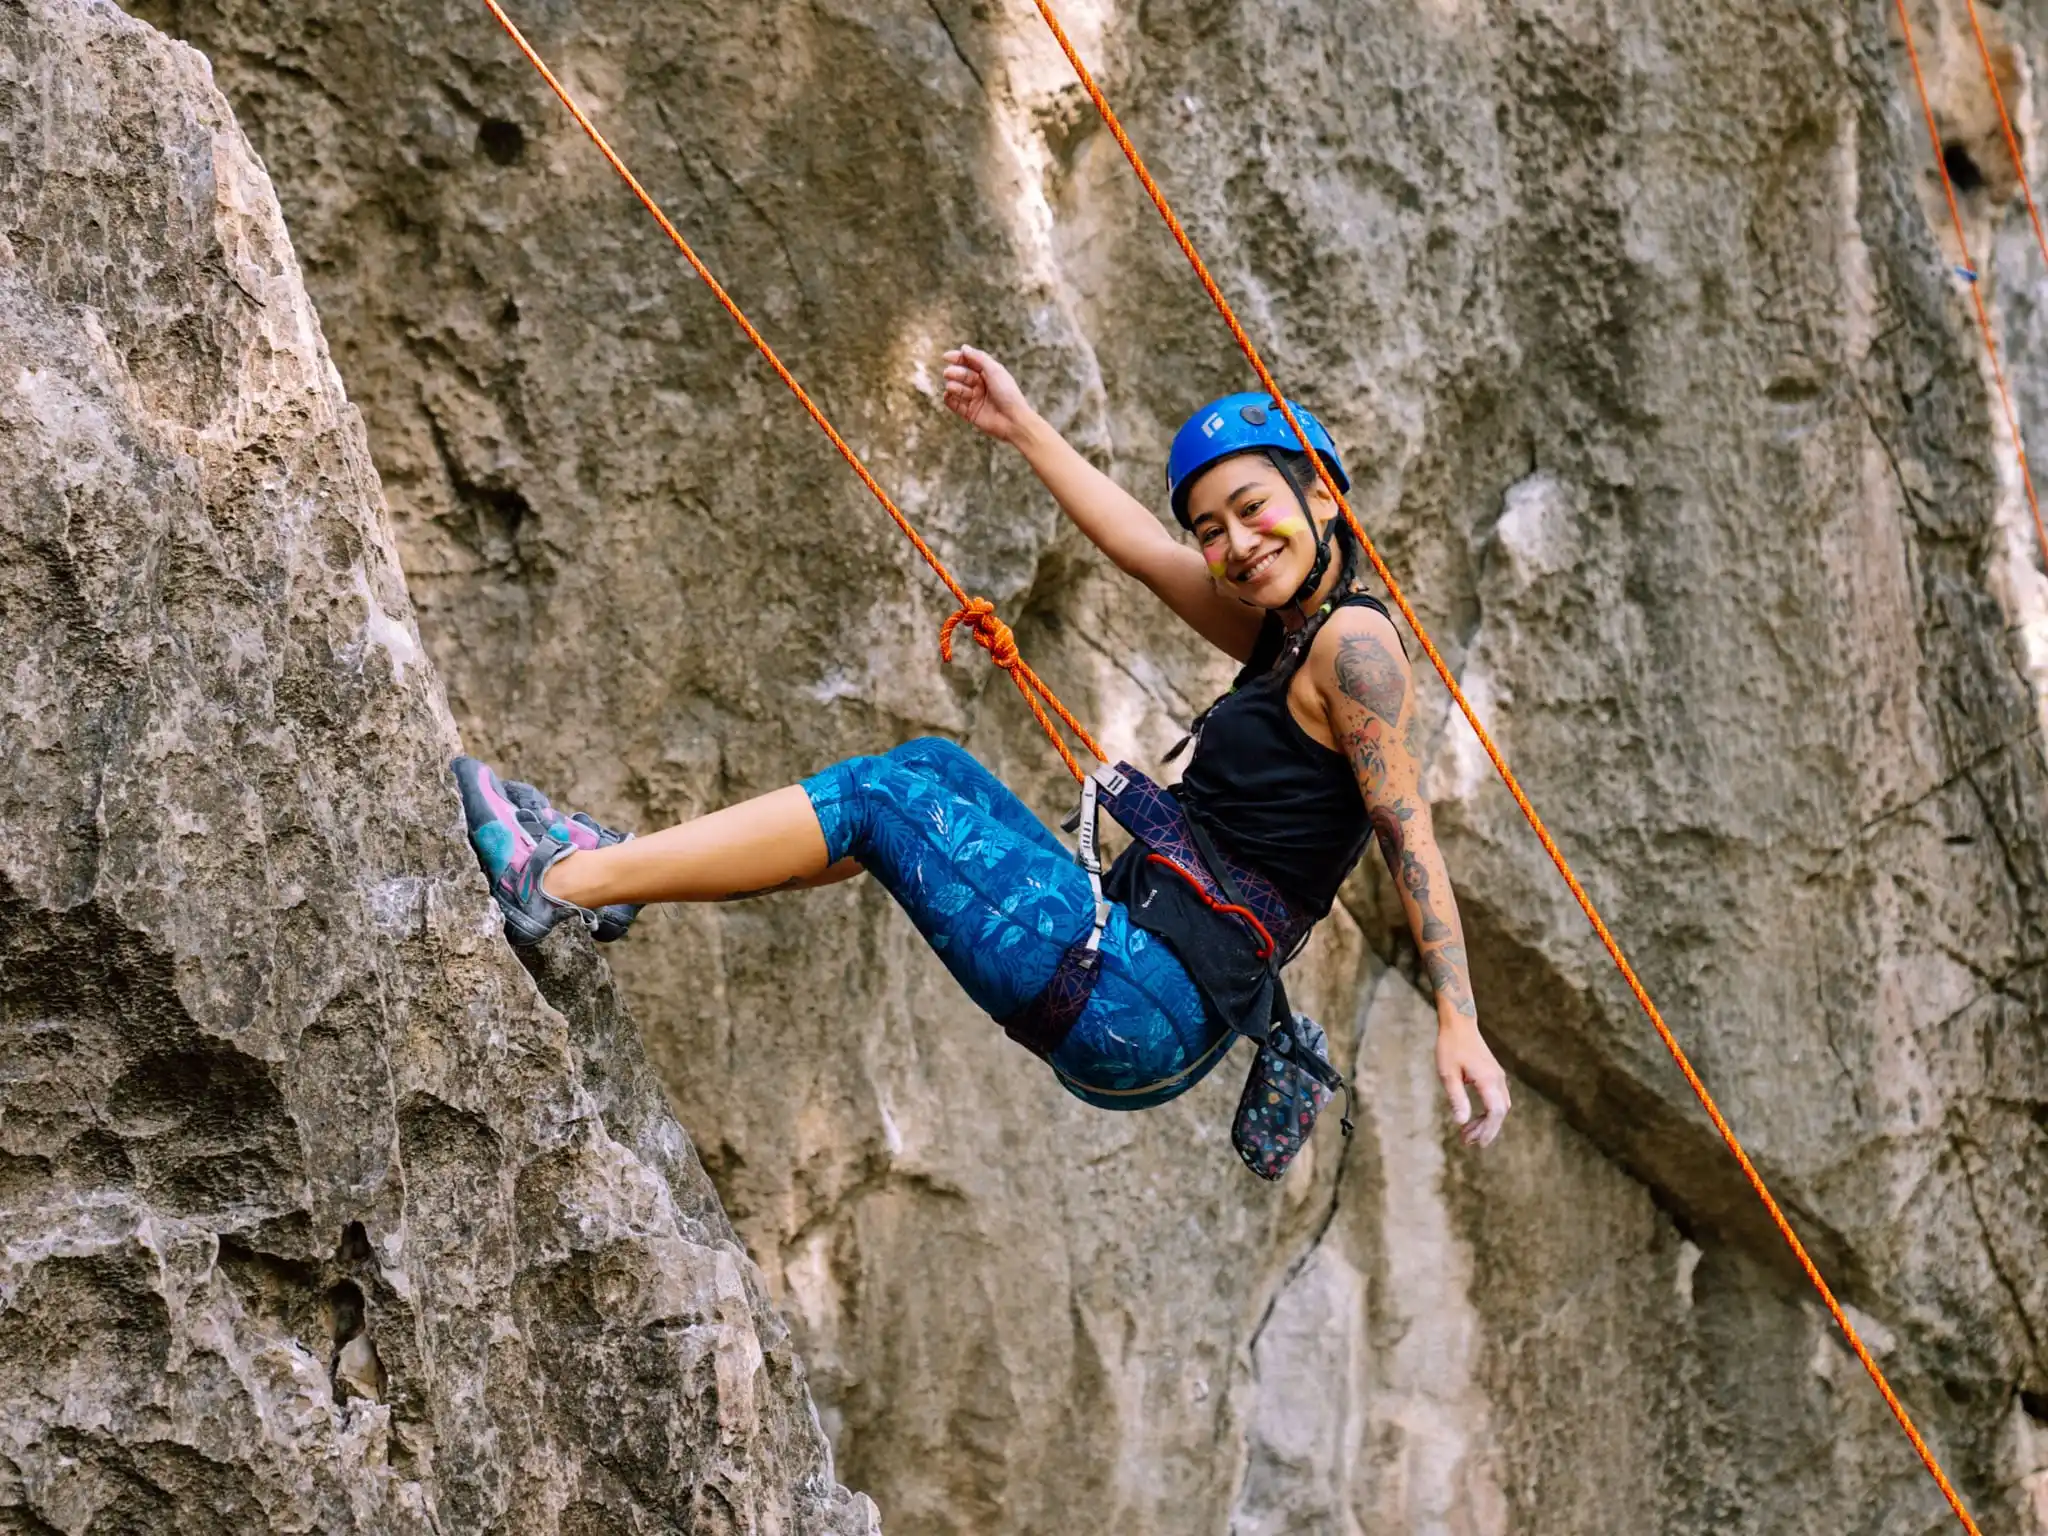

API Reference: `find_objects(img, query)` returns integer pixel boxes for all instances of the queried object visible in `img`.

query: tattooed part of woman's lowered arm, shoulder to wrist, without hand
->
[1329,631,1479,1018]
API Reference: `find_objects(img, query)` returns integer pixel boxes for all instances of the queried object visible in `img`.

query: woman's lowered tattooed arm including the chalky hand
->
[1309,608,1507,1147]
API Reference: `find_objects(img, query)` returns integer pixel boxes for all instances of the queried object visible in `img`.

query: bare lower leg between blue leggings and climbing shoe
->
[543,784,860,907]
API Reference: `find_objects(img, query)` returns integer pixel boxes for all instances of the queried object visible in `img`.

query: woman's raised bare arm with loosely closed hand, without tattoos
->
[946,346,1264,662]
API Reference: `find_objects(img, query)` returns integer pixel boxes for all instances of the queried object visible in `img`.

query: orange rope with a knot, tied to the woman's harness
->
[483,0,1108,780]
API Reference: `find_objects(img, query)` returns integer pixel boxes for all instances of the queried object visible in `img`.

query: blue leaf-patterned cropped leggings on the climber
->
[803,737,1231,1110]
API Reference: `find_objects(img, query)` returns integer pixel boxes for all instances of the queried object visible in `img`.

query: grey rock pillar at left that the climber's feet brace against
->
[0,0,877,1536]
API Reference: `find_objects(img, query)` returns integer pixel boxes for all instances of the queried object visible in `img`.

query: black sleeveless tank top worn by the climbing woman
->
[1176,592,1386,918]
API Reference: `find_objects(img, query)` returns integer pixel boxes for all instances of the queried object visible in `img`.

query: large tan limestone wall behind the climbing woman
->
[88,0,2048,1536]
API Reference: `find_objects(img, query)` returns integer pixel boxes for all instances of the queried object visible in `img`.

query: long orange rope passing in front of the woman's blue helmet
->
[1032,0,1980,1536]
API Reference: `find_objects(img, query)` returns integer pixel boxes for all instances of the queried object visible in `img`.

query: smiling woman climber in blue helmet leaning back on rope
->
[455,346,1509,1178]
